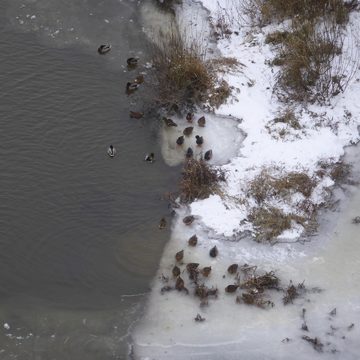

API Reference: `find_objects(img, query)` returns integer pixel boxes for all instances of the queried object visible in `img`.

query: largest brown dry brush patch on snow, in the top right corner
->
[239,0,358,103]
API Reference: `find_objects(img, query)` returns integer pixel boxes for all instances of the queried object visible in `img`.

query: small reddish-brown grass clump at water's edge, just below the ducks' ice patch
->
[180,159,225,202]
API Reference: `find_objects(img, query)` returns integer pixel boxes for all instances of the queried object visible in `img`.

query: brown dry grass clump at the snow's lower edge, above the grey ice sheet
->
[249,207,305,242]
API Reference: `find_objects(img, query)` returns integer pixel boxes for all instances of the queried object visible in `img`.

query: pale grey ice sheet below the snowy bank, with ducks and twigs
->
[134,191,360,360]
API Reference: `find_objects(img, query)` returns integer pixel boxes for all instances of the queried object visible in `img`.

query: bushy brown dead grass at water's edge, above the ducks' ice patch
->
[152,32,232,110]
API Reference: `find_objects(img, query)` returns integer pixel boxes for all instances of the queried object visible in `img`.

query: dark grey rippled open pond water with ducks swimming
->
[0,0,178,360]
